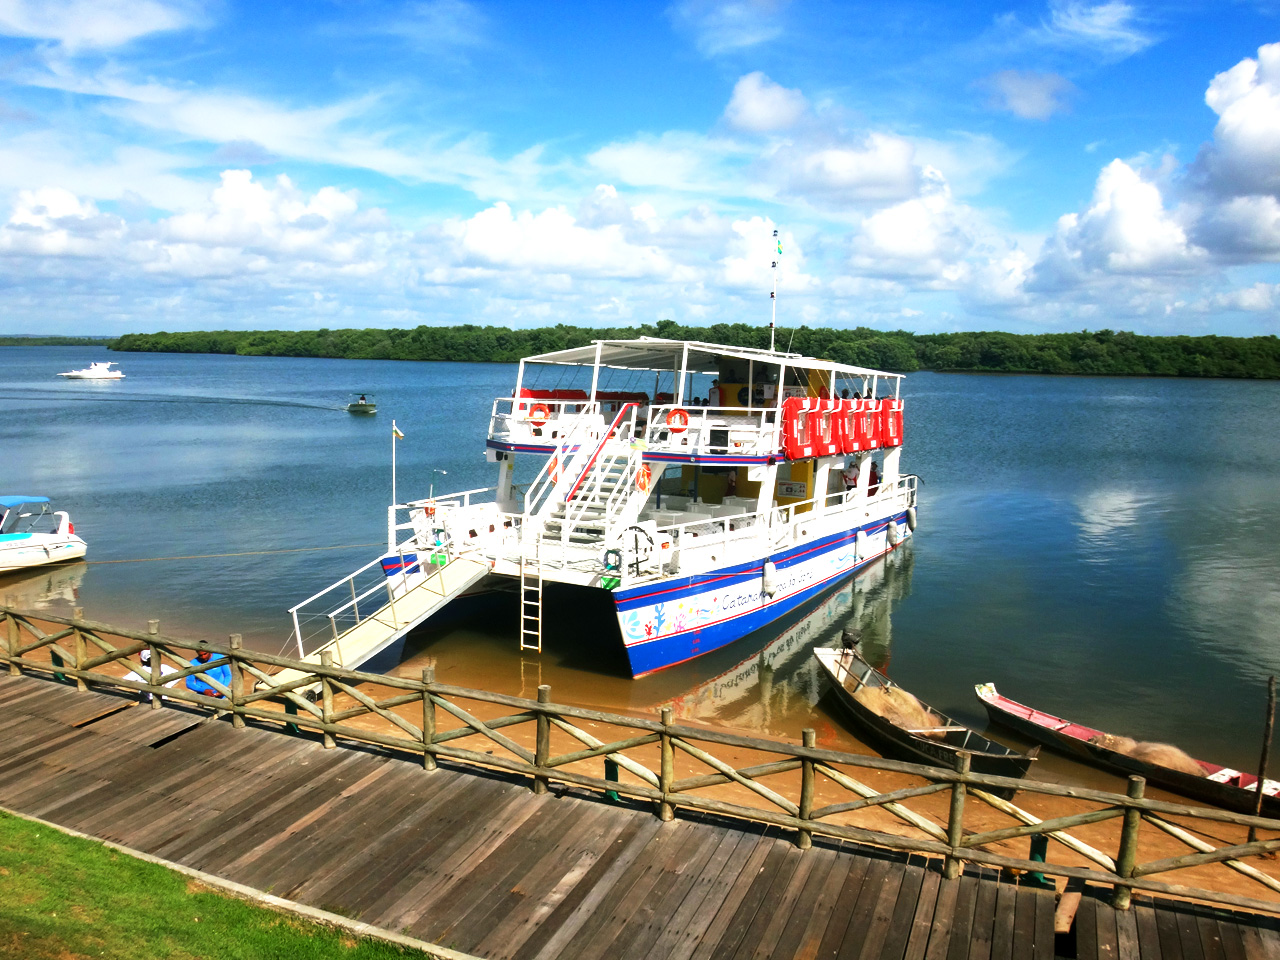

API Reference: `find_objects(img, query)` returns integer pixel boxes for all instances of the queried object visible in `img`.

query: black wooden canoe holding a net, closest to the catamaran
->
[813,646,1039,799]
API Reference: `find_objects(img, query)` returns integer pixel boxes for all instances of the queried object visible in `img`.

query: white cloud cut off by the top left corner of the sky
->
[0,0,205,52]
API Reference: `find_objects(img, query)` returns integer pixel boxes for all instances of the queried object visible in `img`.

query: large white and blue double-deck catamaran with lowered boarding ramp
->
[291,337,916,677]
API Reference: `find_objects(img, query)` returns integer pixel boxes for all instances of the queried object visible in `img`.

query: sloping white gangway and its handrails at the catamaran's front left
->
[260,553,490,686]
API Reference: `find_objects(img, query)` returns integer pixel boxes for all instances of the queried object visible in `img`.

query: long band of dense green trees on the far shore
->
[109,320,1280,379]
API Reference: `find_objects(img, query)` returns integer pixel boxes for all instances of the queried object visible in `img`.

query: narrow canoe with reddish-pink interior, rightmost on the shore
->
[974,684,1280,817]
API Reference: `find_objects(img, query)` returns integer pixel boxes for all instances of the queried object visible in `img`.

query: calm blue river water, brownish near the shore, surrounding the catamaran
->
[0,347,1280,782]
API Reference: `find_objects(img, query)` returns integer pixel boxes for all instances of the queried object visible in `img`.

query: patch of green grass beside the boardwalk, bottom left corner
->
[0,814,429,960]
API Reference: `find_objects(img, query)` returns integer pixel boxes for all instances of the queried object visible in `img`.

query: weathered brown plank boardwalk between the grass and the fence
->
[0,677,1280,960]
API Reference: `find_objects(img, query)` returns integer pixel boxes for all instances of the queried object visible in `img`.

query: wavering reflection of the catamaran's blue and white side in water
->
[666,547,914,732]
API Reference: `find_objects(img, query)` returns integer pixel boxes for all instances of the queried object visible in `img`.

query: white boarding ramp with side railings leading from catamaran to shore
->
[260,545,490,686]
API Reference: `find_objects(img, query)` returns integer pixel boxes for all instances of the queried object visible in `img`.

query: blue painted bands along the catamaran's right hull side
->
[614,512,909,677]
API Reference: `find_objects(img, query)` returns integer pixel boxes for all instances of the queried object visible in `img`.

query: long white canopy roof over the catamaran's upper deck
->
[524,337,902,380]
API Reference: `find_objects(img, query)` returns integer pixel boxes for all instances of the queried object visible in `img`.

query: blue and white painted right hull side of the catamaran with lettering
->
[613,511,910,677]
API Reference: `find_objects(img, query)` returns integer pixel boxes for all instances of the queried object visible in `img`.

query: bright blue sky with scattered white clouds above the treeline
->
[0,0,1280,335]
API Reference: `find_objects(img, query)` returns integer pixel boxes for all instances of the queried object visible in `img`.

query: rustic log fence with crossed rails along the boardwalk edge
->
[0,608,1280,914]
